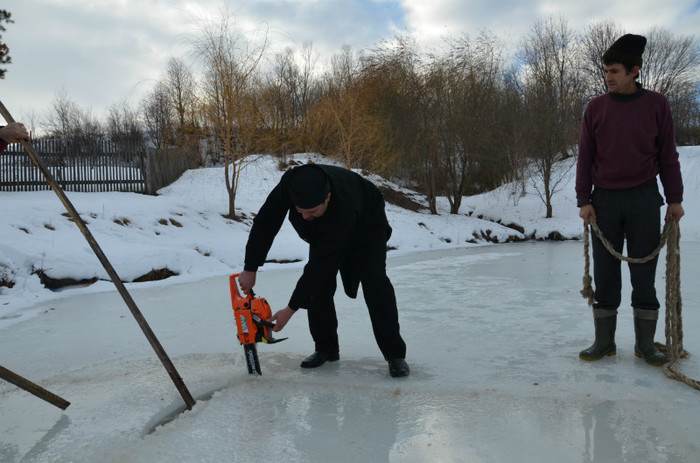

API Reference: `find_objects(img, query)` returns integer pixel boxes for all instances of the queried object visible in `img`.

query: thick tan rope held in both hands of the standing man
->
[581,217,700,390]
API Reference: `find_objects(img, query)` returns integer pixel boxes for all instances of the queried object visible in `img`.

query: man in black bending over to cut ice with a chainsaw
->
[238,164,409,377]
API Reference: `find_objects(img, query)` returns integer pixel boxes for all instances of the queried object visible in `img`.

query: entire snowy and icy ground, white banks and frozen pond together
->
[0,147,700,463]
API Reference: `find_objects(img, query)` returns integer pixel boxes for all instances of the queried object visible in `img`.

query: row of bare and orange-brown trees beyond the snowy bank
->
[17,17,700,216]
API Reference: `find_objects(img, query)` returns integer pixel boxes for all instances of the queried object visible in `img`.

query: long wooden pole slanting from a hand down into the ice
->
[0,101,195,410]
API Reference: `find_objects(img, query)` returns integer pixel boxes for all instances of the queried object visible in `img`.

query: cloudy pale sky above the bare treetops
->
[0,0,700,132]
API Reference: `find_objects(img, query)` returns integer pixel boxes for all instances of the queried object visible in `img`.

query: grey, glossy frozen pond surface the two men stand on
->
[0,242,700,463]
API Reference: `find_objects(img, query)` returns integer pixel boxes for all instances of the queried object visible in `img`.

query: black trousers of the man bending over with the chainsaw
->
[307,236,406,360]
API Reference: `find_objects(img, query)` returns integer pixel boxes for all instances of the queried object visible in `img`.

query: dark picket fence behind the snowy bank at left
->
[0,139,148,193]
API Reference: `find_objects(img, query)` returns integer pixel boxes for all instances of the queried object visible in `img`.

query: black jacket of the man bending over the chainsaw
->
[244,164,391,310]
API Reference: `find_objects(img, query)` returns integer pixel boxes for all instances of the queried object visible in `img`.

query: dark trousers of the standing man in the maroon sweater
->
[591,182,664,310]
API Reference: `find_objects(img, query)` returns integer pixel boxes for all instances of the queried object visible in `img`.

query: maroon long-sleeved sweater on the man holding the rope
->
[576,87,683,206]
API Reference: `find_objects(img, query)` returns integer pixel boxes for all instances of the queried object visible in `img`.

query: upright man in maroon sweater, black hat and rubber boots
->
[576,34,684,365]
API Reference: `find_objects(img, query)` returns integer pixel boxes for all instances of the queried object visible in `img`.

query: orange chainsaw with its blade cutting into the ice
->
[229,273,287,375]
